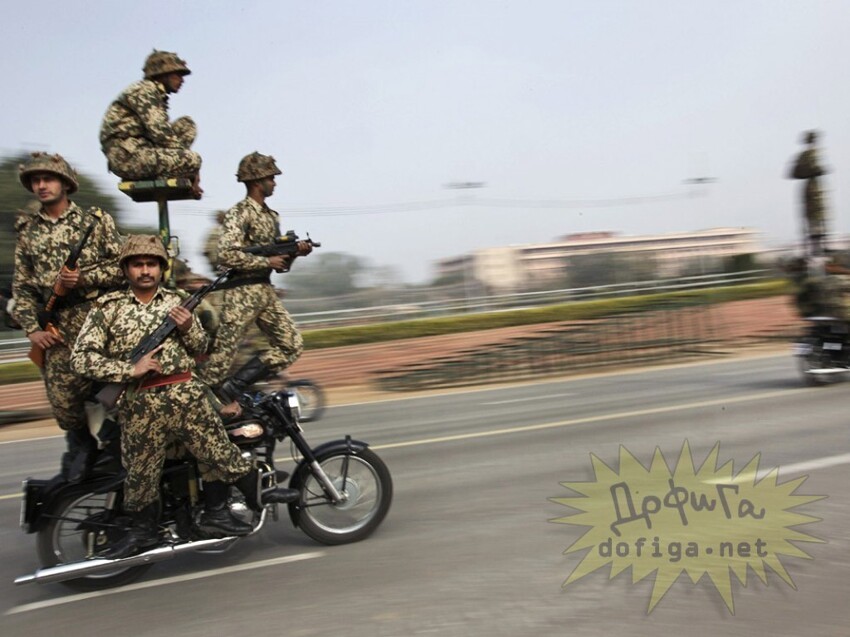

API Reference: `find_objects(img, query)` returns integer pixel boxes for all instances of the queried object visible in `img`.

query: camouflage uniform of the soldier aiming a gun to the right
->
[203,197,304,385]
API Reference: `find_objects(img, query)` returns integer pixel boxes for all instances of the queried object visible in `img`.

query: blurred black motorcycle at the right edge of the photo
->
[793,316,850,385]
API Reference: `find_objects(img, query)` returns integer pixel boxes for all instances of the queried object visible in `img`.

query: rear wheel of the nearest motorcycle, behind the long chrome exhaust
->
[36,489,151,591]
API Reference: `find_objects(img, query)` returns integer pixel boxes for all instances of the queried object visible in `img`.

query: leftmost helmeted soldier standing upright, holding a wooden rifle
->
[12,153,123,480]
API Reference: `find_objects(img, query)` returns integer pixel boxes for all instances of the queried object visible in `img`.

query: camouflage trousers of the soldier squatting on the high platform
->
[104,117,201,180]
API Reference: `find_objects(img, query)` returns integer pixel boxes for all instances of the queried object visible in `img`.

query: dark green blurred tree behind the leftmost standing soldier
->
[0,152,124,295]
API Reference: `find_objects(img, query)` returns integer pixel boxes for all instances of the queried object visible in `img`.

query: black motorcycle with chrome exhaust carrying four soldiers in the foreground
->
[15,390,393,590]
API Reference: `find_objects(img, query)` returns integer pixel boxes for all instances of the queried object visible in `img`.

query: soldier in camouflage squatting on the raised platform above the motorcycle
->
[100,49,203,198]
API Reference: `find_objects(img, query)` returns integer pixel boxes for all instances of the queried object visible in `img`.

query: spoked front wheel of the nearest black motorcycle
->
[289,449,393,545]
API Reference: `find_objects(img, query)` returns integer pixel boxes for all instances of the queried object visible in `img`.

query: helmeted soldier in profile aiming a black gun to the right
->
[197,152,312,401]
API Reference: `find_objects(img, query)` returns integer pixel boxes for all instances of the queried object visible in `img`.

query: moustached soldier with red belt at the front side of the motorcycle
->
[71,235,298,559]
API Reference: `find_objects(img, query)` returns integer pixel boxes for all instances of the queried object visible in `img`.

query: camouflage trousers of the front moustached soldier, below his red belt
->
[118,380,253,511]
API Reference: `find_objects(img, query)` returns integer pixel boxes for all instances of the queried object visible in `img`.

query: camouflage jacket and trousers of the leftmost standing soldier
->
[13,203,124,430]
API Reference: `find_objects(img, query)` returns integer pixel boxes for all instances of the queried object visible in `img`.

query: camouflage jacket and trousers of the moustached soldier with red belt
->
[71,286,253,511]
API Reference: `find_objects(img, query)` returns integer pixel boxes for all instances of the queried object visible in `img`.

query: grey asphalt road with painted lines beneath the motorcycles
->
[0,355,850,637]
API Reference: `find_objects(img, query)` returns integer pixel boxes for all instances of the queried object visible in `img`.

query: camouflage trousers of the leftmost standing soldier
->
[43,345,92,431]
